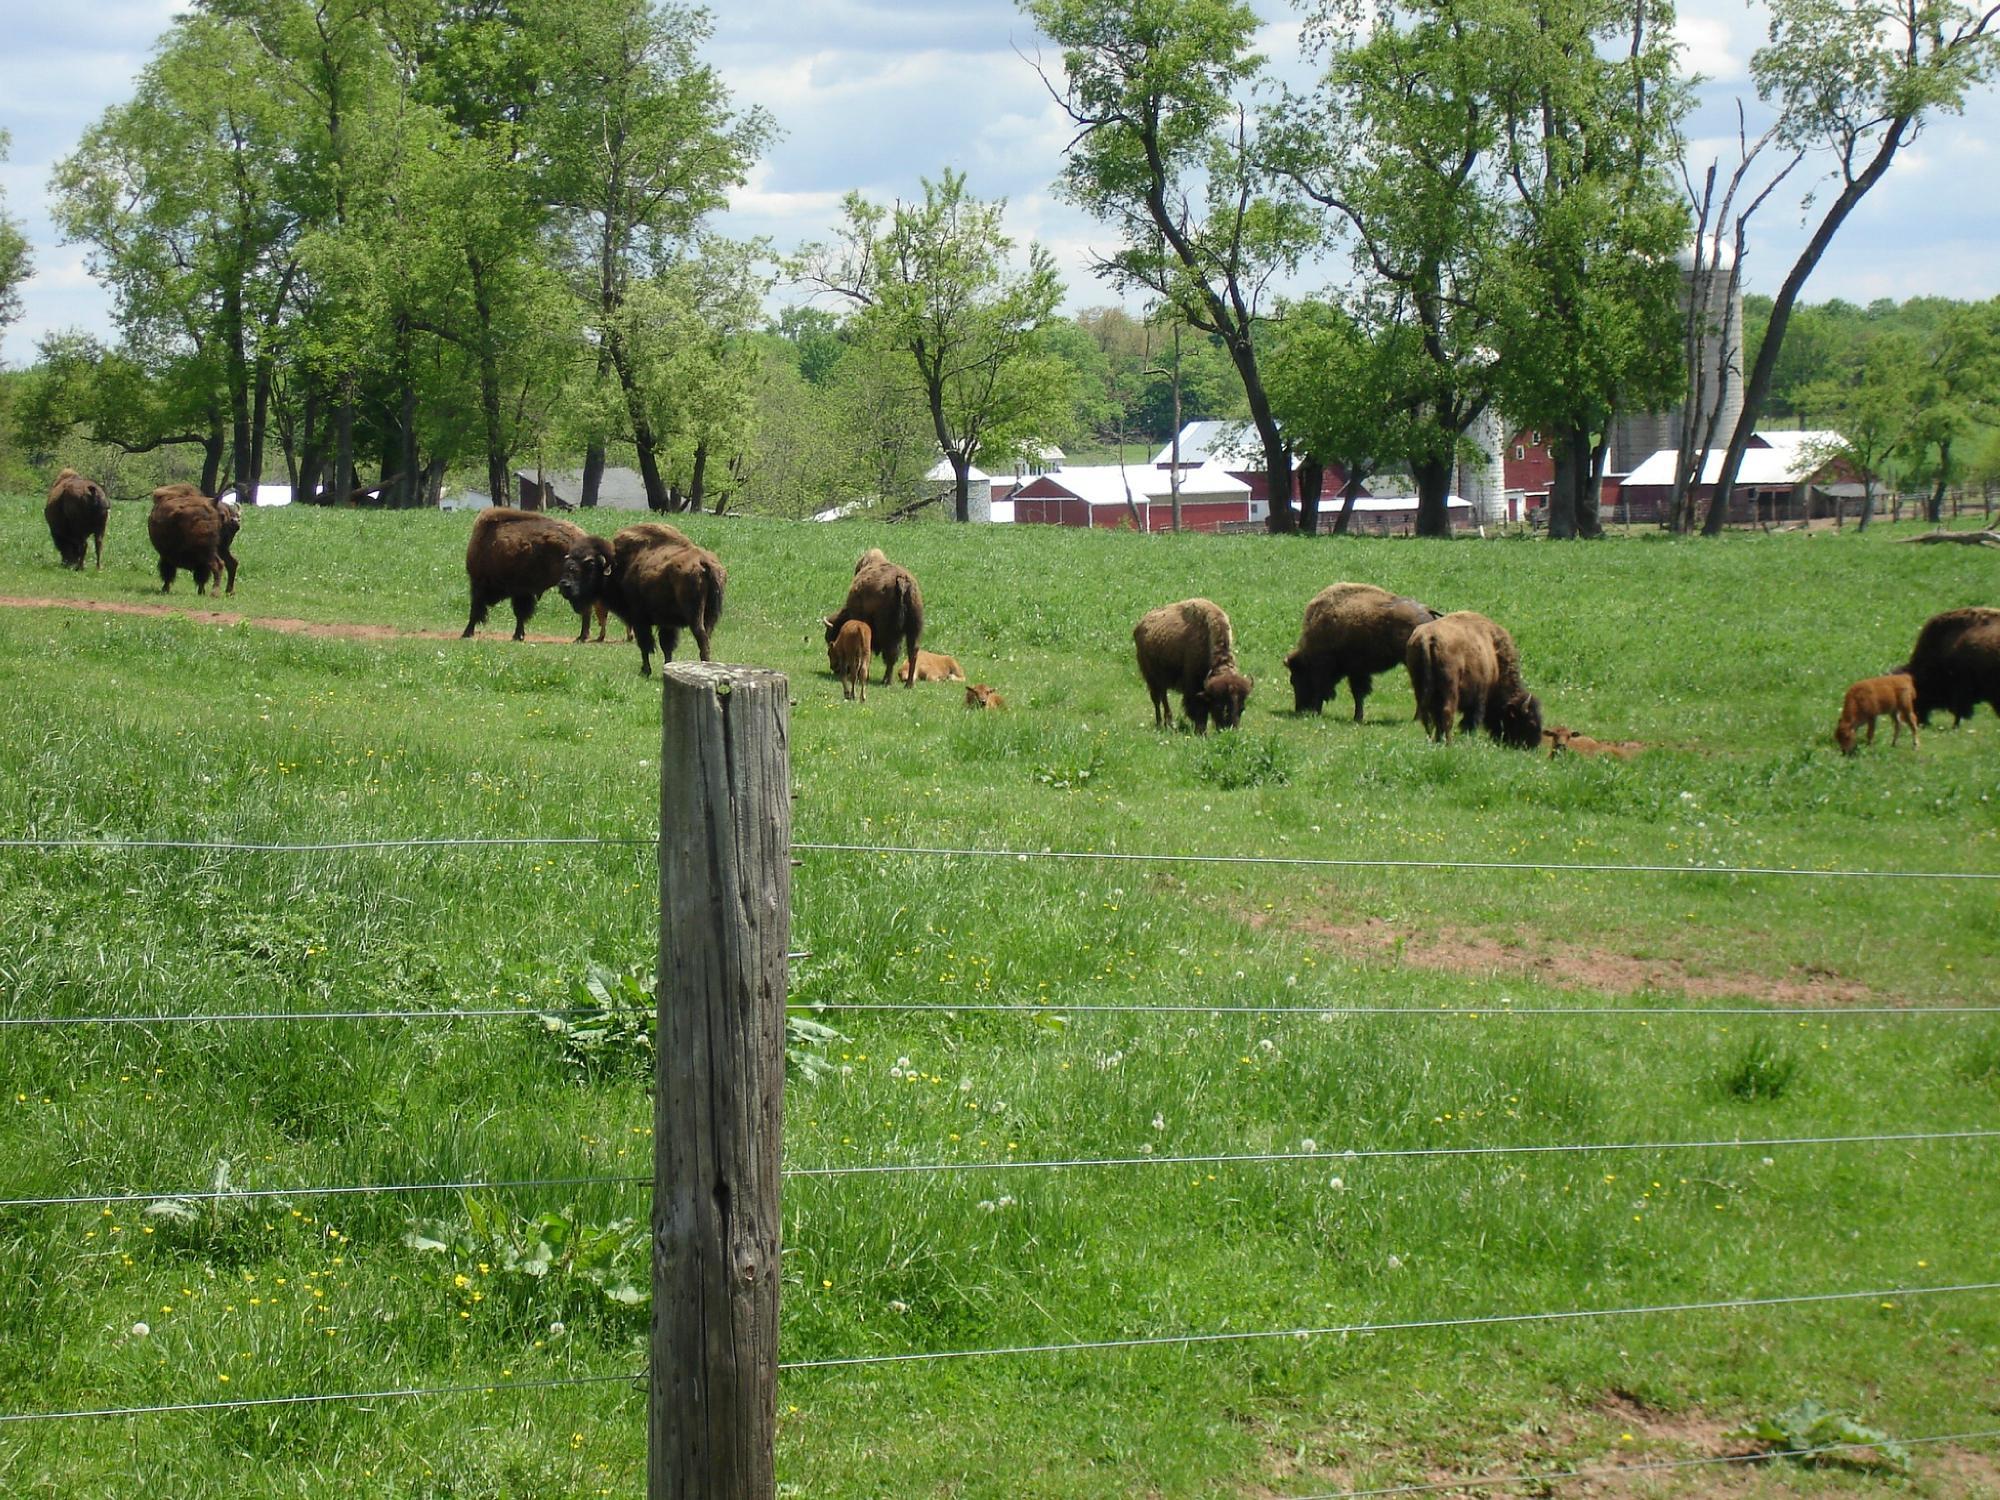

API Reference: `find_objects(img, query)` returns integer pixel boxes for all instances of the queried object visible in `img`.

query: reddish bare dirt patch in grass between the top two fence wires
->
[1248,912,1892,1006]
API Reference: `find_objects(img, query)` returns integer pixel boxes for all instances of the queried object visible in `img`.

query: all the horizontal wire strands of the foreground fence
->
[11,834,2000,1500]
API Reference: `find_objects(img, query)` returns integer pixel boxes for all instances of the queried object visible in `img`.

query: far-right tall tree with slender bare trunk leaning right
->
[1702,0,2000,536]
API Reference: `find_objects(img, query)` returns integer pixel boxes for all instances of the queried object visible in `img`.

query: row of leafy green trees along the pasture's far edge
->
[0,0,1994,536]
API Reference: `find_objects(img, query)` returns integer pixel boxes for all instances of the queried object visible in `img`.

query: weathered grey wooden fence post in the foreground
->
[646,662,792,1500]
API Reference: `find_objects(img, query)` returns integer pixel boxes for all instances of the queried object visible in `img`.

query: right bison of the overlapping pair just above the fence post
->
[556,522,728,676]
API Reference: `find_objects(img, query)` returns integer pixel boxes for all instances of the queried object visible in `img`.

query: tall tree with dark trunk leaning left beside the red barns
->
[1024,0,1316,532]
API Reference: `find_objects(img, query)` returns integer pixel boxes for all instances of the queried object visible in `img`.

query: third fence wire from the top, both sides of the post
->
[0,1130,2000,1210]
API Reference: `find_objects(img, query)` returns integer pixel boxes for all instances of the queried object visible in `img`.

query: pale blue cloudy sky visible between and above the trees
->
[0,0,2000,366]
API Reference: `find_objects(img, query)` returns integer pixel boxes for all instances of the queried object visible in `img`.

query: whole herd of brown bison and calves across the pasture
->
[27,468,2000,758]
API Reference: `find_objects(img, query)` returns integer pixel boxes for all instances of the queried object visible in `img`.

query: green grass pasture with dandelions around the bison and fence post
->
[0,498,2000,1500]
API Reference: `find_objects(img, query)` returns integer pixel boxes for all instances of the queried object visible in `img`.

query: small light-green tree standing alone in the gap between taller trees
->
[802,168,1070,520]
